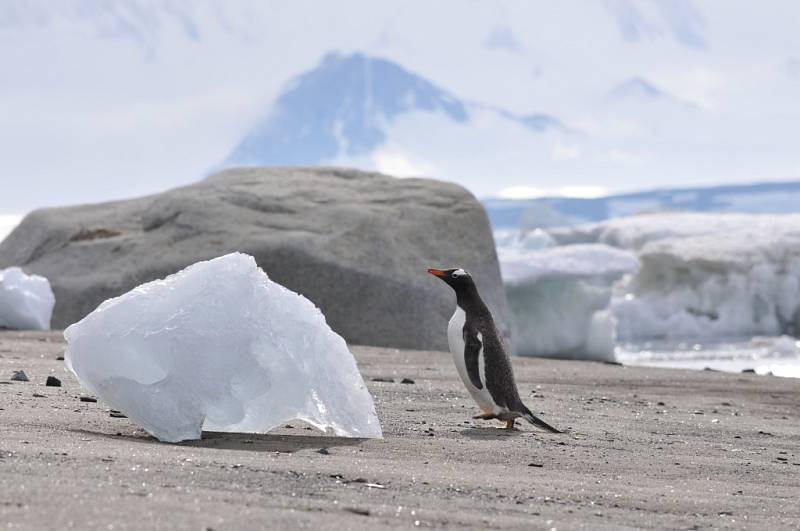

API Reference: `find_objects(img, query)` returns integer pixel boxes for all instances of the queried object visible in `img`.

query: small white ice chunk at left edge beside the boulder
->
[0,267,56,330]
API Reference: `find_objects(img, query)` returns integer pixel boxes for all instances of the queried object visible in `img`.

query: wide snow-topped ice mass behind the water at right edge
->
[551,213,800,341]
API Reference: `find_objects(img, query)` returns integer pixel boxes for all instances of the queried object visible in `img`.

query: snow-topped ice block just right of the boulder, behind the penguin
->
[498,242,638,360]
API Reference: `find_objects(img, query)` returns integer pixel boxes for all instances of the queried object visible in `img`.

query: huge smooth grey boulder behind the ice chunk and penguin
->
[0,168,508,349]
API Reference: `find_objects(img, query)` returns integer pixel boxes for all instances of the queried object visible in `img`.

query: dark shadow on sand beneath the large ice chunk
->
[69,429,367,453]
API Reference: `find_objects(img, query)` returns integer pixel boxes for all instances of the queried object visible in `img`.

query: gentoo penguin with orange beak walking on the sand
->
[428,268,561,433]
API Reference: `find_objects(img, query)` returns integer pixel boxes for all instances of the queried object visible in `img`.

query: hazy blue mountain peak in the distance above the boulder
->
[222,53,565,173]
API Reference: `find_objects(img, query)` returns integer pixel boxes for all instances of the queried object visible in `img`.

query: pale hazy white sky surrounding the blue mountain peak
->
[0,0,800,236]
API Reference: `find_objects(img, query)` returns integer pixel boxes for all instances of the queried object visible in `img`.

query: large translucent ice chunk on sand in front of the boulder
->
[64,253,381,442]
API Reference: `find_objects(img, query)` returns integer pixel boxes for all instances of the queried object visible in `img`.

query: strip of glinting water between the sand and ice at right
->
[615,336,800,378]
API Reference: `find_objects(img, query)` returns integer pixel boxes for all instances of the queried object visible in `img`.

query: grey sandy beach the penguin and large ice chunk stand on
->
[0,332,800,530]
